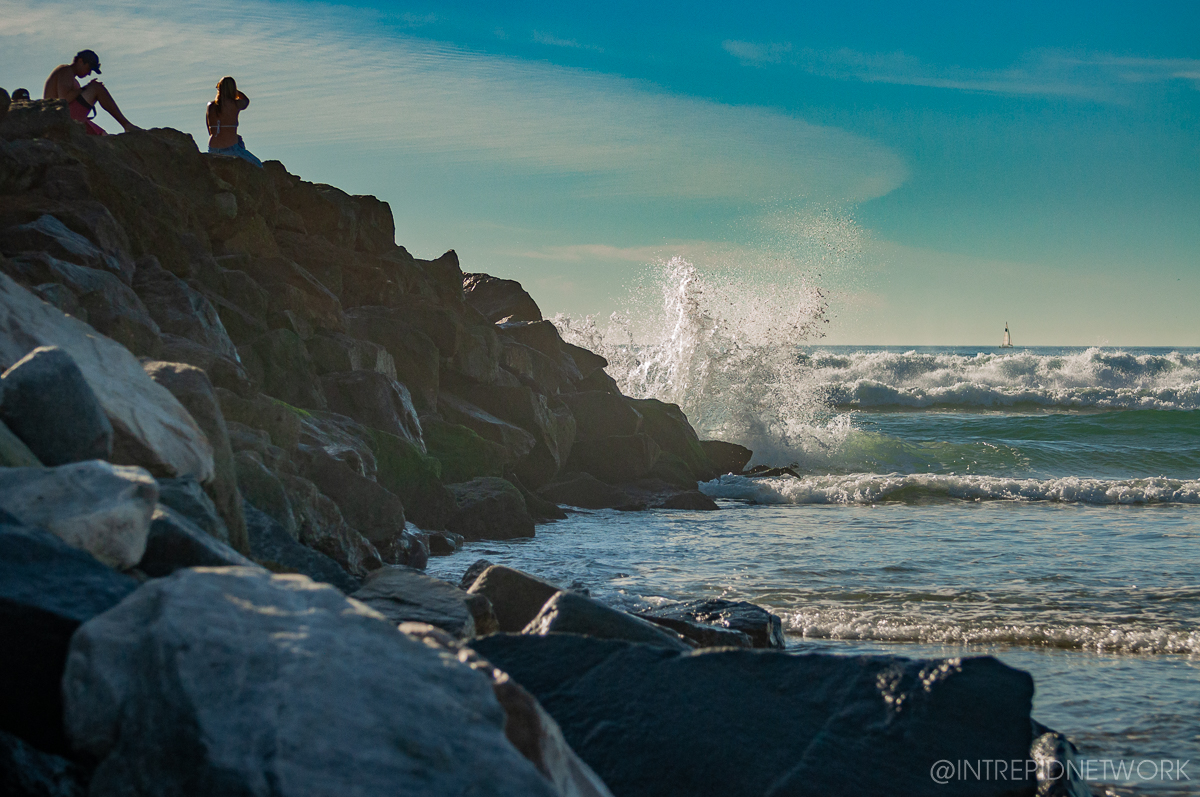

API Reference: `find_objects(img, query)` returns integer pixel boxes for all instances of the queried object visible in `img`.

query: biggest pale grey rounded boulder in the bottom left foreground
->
[64,568,556,797]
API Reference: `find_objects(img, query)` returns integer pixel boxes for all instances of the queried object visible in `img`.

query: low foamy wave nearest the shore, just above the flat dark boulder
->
[782,610,1200,655]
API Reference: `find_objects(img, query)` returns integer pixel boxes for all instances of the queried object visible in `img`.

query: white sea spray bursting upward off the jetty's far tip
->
[553,257,851,467]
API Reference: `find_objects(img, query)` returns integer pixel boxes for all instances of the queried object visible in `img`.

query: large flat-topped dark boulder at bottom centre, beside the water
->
[472,634,1037,797]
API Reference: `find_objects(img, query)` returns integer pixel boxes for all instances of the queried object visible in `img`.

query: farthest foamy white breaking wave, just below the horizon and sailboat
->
[806,348,1200,409]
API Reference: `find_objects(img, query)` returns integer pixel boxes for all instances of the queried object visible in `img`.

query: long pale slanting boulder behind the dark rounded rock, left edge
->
[0,275,214,483]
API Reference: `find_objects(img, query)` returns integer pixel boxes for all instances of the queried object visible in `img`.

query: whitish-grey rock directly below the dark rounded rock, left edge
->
[0,460,158,570]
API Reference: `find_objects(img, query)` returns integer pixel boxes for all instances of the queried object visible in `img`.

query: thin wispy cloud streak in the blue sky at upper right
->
[722,40,1200,102]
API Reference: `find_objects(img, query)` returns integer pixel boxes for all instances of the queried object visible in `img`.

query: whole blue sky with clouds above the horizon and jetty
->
[0,0,1200,346]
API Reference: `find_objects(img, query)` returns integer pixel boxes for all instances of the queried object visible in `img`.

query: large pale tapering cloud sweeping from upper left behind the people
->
[0,0,906,202]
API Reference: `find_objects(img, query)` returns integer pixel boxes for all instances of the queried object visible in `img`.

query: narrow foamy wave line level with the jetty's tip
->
[700,473,1200,505]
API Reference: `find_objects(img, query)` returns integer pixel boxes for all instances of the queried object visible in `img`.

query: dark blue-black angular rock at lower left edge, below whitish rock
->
[0,521,138,753]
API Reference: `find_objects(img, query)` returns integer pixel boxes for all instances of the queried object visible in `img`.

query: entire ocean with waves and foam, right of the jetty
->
[430,343,1200,796]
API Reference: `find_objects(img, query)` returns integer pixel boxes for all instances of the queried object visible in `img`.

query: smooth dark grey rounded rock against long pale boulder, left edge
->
[0,346,113,466]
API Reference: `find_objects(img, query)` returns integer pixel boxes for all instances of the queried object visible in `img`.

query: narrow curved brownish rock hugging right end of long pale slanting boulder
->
[142,361,248,551]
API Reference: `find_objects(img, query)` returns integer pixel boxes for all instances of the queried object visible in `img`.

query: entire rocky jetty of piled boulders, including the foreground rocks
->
[0,101,1089,797]
